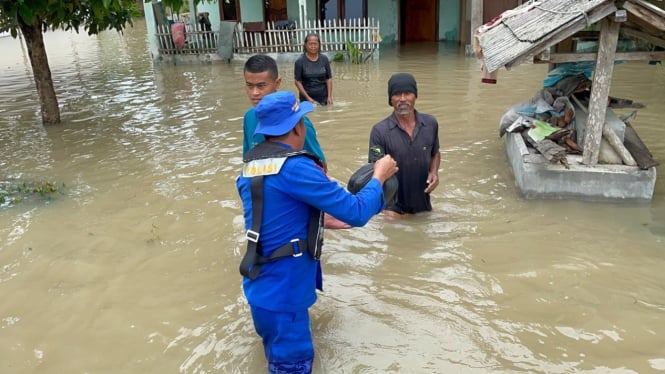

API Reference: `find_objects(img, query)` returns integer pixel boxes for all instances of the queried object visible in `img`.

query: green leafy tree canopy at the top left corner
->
[0,0,139,37]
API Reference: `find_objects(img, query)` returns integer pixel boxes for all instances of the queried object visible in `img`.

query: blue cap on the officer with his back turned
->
[254,91,314,136]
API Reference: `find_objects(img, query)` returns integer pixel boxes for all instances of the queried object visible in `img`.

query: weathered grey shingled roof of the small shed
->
[476,0,665,72]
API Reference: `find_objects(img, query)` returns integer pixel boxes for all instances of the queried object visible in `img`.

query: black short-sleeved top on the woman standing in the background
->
[293,54,332,105]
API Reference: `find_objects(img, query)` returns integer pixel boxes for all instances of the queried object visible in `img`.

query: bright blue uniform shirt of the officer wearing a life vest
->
[236,144,384,312]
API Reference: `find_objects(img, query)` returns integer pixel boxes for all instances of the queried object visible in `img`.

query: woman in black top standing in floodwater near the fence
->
[294,34,333,105]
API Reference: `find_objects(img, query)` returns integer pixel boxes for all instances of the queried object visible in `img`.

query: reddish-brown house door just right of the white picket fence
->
[400,0,439,43]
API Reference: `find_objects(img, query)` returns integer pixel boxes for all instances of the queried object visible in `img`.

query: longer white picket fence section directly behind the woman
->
[233,18,381,54]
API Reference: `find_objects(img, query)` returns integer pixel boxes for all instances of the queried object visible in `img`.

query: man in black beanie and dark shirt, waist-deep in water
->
[368,73,441,216]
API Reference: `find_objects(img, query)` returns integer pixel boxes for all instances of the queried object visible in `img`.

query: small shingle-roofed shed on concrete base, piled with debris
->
[474,0,665,200]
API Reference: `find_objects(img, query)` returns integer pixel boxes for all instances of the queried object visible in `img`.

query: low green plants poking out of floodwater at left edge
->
[0,179,65,208]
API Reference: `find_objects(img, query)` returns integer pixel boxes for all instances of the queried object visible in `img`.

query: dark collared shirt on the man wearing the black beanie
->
[368,111,439,213]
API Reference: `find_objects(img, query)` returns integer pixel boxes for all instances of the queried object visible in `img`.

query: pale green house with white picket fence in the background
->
[144,0,522,61]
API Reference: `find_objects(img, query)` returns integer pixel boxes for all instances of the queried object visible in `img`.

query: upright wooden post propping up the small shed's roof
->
[582,18,620,166]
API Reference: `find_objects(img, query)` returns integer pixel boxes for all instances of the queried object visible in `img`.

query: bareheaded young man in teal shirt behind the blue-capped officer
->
[242,55,327,170]
